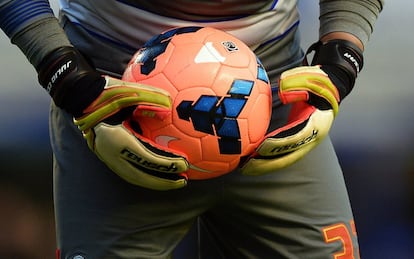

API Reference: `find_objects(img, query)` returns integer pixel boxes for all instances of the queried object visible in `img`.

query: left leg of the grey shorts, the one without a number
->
[50,106,209,258]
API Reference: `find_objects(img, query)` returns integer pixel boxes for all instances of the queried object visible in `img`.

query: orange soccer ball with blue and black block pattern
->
[123,27,272,179]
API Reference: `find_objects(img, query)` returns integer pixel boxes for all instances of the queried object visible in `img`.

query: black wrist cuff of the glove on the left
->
[36,46,105,117]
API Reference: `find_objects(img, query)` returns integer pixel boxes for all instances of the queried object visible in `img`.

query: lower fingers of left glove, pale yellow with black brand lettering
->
[91,123,189,190]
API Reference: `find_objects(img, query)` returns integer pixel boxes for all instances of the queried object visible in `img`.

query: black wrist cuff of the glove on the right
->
[304,40,364,100]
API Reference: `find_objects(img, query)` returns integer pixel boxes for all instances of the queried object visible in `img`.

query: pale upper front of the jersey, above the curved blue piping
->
[60,0,299,50]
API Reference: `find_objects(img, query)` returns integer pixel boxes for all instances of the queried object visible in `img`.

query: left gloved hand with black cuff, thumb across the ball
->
[37,47,188,190]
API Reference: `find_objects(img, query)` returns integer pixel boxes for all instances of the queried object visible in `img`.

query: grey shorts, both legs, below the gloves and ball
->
[50,16,358,259]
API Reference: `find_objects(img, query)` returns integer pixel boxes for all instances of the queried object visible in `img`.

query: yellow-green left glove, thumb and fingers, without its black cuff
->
[74,77,189,190]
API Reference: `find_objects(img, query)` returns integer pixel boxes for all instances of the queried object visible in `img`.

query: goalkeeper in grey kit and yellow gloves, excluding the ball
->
[0,0,383,259]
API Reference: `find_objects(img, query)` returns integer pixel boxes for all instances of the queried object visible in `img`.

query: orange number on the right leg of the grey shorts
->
[323,222,356,259]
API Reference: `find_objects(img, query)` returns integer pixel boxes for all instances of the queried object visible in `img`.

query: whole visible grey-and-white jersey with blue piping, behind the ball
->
[60,0,303,87]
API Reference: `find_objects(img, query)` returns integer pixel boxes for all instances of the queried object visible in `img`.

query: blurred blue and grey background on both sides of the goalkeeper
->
[0,0,414,259]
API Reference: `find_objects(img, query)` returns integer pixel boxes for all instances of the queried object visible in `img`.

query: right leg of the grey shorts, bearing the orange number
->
[200,140,358,258]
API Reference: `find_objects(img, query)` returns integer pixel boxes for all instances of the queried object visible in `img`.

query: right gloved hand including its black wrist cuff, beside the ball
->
[241,40,363,175]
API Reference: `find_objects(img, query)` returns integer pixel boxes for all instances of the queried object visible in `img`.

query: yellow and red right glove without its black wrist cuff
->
[242,67,338,175]
